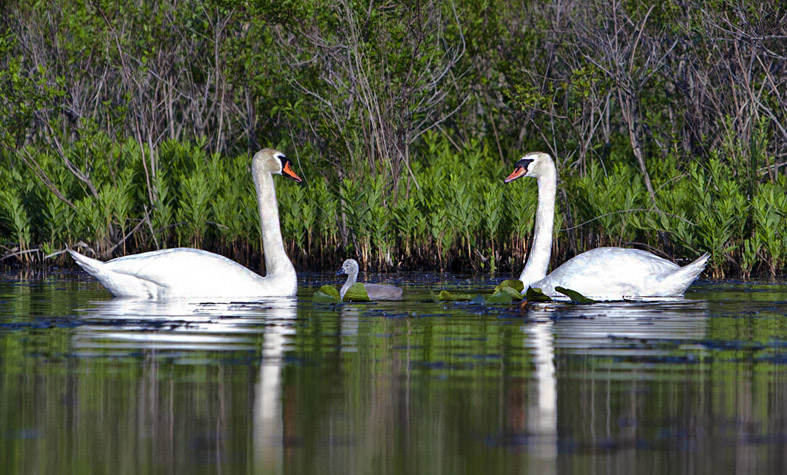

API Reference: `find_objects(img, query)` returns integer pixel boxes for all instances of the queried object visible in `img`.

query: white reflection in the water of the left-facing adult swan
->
[522,299,708,473]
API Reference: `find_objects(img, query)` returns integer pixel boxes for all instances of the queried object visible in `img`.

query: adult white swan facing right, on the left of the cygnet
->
[69,148,301,300]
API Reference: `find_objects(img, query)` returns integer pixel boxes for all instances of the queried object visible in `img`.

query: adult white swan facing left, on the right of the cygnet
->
[505,152,709,300]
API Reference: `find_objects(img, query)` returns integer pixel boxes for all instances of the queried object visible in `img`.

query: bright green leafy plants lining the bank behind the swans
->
[0,130,787,277]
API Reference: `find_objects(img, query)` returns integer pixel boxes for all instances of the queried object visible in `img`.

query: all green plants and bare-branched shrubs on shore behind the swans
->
[0,0,787,277]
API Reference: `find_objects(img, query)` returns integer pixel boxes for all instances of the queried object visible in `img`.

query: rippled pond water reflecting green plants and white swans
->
[0,274,787,474]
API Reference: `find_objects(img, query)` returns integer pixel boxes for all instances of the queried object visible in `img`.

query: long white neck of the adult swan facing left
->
[519,165,557,289]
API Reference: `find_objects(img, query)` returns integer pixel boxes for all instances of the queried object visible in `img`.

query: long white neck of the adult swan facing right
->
[253,169,295,277]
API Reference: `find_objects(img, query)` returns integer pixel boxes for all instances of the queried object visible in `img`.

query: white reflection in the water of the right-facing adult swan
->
[72,298,297,473]
